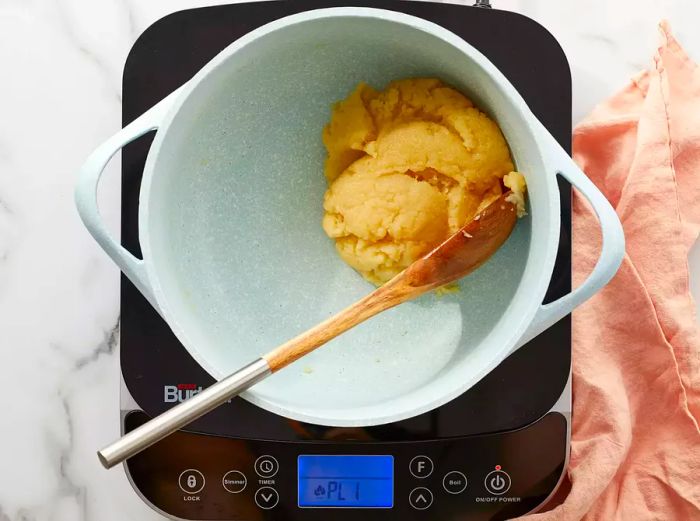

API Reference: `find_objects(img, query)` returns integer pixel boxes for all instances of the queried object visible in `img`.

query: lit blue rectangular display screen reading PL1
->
[298,455,394,508]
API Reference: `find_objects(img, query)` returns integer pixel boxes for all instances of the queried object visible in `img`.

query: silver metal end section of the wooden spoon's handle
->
[97,358,272,468]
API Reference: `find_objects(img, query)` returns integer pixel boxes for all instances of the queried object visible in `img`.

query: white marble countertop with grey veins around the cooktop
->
[0,0,700,521]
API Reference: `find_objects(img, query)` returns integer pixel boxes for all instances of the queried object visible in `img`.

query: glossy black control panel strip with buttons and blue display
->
[125,411,567,521]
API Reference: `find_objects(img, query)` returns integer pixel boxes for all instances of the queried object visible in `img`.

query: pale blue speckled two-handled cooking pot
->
[76,7,624,426]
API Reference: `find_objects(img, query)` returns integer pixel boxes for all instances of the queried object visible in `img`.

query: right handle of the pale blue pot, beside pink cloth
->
[513,138,625,351]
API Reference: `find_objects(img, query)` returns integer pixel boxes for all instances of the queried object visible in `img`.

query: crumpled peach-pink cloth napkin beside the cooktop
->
[527,23,700,521]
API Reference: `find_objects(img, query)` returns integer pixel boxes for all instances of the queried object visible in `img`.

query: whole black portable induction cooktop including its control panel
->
[120,0,571,521]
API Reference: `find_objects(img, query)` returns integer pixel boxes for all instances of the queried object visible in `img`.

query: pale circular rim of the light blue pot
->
[138,7,560,427]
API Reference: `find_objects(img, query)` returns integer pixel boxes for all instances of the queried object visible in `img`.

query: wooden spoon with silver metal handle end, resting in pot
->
[97,192,516,468]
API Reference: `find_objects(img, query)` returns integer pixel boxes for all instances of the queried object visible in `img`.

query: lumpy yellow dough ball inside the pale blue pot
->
[323,79,525,284]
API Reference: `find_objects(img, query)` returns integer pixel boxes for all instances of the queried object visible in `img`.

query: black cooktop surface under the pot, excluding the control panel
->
[121,0,571,441]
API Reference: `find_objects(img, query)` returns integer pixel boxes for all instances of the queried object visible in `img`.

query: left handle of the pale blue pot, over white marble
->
[75,89,179,309]
